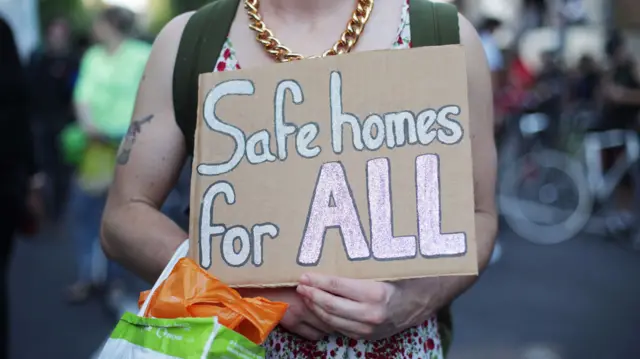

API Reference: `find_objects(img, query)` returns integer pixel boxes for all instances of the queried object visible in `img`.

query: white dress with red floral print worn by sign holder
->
[215,1,444,359]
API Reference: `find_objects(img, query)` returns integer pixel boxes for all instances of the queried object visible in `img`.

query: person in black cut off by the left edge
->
[0,17,38,358]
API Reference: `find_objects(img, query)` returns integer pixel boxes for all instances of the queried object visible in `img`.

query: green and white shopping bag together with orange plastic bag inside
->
[98,242,287,359]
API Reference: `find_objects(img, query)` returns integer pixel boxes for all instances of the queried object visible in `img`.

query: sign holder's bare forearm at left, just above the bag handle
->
[101,202,188,283]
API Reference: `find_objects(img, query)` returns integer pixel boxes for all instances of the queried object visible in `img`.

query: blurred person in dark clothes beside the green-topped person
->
[27,19,79,221]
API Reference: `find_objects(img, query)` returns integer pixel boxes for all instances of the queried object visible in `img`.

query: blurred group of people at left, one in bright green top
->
[0,7,151,358]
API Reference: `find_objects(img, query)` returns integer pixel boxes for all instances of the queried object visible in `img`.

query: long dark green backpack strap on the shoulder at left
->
[173,0,239,155]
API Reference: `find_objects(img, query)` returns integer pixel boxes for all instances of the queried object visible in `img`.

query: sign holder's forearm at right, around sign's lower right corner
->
[399,213,497,327]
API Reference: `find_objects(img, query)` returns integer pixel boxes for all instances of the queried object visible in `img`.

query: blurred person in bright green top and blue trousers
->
[68,7,151,303]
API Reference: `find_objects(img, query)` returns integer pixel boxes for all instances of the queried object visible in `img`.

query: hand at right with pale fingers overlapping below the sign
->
[297,274,412,340]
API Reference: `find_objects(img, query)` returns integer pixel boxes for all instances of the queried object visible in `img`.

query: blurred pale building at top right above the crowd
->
[458,0,616,69]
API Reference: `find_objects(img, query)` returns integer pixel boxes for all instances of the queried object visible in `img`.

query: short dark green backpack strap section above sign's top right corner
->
[409,0,460,47]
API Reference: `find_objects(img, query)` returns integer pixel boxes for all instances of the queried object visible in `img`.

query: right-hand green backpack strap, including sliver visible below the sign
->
[409,0,460,356]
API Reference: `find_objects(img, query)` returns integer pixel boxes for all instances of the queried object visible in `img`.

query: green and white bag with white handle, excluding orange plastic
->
[97,242,265,359]
